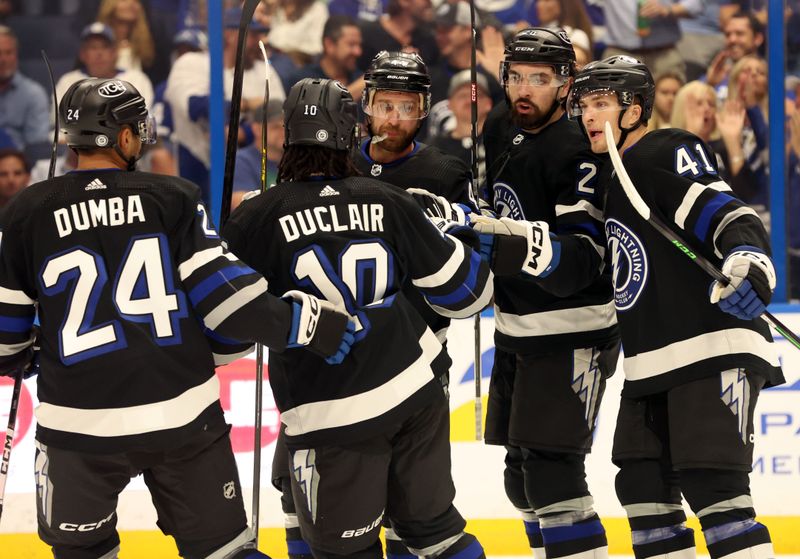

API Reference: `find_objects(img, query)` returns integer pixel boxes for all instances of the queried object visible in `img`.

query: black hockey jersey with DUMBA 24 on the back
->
[0,170,298,453]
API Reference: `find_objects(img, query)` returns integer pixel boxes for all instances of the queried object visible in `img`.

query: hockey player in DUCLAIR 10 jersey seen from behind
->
[223,79,492,559]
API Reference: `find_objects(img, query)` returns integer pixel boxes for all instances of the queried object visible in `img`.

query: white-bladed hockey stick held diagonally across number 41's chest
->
[605,122,800,349]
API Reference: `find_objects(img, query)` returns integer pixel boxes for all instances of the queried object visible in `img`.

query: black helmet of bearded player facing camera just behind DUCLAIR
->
[361,50,431,118]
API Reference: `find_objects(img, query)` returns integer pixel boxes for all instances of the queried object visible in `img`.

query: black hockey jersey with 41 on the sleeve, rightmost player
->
[605,129,784,397]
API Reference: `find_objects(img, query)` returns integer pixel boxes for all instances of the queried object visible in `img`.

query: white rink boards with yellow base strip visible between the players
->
[0,312,800,559]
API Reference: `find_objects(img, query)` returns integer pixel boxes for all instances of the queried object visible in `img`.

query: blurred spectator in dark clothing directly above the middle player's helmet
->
[358,0,438,72]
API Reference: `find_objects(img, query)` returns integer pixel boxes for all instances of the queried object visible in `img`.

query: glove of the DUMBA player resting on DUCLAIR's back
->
[283,290,355,365]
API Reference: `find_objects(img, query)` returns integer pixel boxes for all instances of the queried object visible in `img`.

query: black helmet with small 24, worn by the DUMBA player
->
[58,78,156,149]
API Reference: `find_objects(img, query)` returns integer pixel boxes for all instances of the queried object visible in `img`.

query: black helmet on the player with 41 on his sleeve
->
[569,56,656,122]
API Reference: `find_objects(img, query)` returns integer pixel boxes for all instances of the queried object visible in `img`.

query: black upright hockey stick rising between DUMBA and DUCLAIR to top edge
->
[219,0,261,229]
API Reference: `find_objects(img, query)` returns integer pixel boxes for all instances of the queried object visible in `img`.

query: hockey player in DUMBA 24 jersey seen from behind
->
[0,78,353,559]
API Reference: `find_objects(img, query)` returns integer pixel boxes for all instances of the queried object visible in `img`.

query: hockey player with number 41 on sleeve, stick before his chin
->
[570,56,784,559]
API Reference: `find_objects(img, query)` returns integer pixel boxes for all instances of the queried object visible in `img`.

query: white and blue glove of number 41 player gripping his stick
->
[710,246,776,320]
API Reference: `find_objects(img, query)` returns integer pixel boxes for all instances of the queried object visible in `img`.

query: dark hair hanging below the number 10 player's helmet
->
[278,145,361,182]
